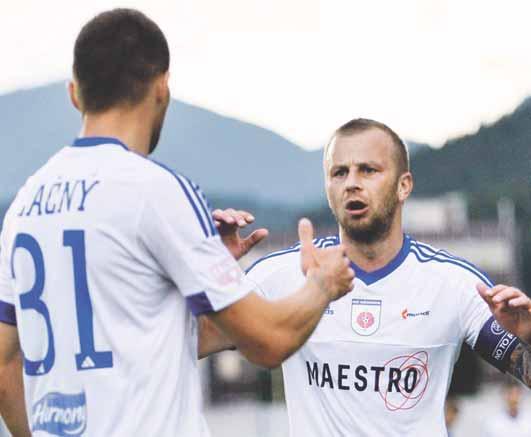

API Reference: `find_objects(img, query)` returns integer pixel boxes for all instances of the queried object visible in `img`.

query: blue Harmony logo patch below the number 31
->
[31,392,87,437]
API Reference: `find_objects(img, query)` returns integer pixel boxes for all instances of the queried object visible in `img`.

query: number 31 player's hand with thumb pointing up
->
[299,218,354,300]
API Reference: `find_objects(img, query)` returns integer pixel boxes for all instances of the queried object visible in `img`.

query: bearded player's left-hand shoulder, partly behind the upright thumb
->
[246,236,338,275]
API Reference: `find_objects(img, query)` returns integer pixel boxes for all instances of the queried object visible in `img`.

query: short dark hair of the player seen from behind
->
[73,9,170,113]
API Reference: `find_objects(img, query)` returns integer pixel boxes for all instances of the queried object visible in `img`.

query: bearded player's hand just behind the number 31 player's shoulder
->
[212,208,269,259]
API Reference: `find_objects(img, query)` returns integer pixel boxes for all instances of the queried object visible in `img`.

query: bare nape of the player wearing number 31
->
[79,106,151,156]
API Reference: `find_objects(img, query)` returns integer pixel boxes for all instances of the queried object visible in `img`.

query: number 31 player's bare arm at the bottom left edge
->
[0,353,31,437]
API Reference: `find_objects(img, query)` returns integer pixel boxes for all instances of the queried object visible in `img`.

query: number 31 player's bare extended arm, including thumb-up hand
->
[208,220,354,368]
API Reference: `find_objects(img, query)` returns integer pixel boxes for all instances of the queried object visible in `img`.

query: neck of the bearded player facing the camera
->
[339,211,404,272]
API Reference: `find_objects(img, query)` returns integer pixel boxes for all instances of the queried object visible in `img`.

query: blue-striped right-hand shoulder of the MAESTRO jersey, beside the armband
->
[409,238,492,286]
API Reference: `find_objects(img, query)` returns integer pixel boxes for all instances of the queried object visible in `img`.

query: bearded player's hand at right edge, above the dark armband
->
[476,283,531,344]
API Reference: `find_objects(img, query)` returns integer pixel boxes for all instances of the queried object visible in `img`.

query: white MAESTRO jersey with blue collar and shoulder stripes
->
[247,236,499,437]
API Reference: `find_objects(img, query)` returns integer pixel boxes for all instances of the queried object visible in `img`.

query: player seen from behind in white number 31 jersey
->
[0,9,354,437]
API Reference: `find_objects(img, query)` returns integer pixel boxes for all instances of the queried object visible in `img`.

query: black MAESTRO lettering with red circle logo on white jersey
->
[306,351,430,411]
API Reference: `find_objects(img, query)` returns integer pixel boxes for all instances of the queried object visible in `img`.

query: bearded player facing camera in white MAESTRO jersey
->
[210,119,531,437]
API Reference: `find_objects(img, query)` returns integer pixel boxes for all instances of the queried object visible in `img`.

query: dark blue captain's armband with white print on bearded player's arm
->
[474,317,521,373]
